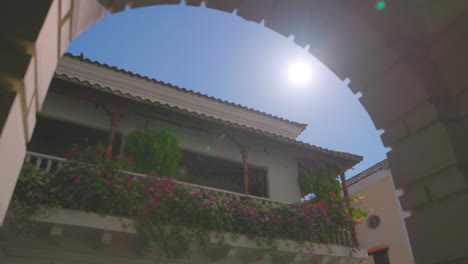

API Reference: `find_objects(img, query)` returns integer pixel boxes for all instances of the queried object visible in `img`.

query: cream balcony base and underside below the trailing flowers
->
[0,209,367,264]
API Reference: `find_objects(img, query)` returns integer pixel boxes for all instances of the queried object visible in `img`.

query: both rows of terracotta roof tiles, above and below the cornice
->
[55,54,362,165]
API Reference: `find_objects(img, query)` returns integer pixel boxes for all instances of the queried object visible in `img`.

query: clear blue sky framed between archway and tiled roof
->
[68,5,388,177]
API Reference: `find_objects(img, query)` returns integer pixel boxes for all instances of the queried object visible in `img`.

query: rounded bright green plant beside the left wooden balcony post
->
[124,125,181,177]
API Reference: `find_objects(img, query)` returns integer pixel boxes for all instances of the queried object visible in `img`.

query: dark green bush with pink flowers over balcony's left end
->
[9,144,141,233]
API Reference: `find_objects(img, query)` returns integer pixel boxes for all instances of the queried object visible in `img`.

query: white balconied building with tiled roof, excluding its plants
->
[0,54,367,264]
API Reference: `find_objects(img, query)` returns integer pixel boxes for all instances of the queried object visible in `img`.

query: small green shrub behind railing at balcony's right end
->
[299,167,341,201]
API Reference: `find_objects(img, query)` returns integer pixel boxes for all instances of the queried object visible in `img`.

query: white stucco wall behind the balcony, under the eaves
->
[41,93,300,202]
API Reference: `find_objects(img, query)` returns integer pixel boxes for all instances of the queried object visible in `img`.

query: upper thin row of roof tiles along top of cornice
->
[64,53,307,132]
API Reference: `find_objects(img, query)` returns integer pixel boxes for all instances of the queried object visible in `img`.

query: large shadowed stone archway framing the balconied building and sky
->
[0,0,468,263]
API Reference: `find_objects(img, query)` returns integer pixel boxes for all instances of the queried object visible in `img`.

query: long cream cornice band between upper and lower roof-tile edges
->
[56,56,305,139]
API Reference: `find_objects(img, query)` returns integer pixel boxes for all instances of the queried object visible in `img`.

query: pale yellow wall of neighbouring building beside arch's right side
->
[353,170,413,264]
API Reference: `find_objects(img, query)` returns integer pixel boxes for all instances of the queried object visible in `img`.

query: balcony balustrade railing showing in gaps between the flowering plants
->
[25,152,355,246]
